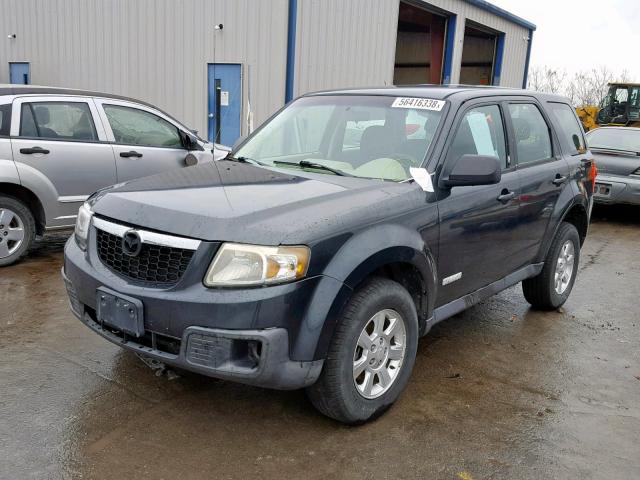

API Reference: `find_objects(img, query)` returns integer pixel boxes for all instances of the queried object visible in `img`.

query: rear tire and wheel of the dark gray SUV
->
[522,222,580,310]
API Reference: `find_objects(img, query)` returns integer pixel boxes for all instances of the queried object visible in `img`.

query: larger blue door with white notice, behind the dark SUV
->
[208,63,242,146]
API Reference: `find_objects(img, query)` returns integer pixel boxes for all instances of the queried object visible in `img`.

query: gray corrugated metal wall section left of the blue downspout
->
[0,0,288,139]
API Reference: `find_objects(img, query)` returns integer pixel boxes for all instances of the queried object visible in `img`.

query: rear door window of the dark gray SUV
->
[509,103,553,165]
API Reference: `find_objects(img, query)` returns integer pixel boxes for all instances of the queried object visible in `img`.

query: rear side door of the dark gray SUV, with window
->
[505,100,569,263]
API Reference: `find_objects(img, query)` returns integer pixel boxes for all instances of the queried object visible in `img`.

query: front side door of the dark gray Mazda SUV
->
[436,101,520,306]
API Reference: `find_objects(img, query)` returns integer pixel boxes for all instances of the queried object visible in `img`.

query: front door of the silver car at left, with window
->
[96,99,189,182]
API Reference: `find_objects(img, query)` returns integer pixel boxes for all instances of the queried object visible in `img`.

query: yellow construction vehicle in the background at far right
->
[576,83,640,130]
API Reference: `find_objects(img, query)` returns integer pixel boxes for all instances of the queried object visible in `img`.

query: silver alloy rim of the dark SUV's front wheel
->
[353,309,407,399]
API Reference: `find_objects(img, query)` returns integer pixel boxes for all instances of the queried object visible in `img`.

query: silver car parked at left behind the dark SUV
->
[0,85,228,267]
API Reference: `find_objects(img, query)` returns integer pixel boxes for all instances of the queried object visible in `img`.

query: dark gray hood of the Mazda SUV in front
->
[91,160,424,245]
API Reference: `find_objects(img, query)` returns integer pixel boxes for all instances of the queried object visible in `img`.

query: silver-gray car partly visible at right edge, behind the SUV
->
[587,127,640,205]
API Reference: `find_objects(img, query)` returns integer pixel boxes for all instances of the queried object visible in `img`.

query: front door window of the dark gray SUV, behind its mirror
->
[447,105,509,169]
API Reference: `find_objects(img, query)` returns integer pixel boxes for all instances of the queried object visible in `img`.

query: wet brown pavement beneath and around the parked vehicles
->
[0,207,640,480]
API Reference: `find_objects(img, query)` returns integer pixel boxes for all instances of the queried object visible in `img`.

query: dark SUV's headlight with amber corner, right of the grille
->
[204,243,310,287]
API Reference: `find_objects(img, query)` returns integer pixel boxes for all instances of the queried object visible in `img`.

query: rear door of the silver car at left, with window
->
[11,96,116,226]
